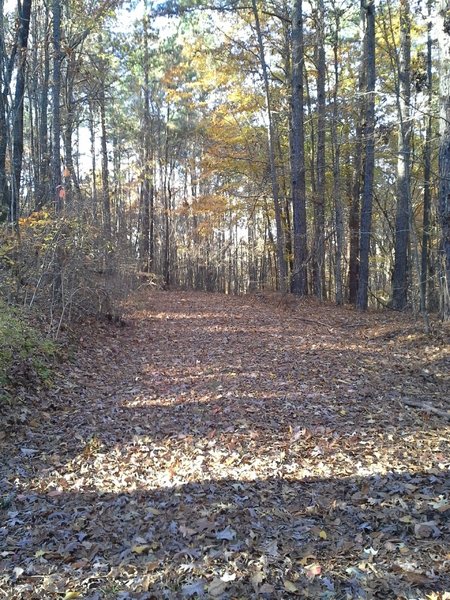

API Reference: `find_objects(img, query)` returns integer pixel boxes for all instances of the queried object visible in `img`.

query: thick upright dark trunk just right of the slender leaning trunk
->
[291,0,308,296]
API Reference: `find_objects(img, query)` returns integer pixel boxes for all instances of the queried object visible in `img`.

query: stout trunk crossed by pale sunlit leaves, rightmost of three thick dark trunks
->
[392,0,411,310]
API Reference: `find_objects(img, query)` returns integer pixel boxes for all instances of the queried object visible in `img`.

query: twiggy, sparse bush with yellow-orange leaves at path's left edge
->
[0,211,138,337]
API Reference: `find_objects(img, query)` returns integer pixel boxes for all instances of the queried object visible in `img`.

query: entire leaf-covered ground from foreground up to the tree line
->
[0,292,450,600]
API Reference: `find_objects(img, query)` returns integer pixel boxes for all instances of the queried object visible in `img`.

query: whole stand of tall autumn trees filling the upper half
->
[0,0,450,319]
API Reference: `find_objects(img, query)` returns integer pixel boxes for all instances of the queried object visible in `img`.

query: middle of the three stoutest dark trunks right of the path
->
[356,0,376,310]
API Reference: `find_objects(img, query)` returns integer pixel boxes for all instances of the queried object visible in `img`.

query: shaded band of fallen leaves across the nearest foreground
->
[0,470,450,600]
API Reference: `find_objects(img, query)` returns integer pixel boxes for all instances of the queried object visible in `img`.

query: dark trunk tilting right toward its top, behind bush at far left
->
[10,0,31,227]
